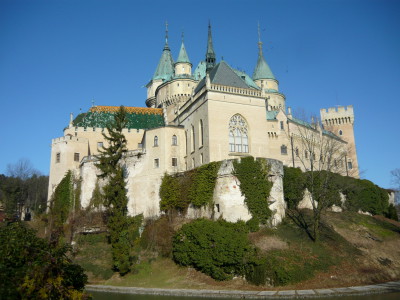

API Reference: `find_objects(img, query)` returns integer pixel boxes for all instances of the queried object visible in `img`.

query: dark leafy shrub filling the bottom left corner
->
[0,223,87,299]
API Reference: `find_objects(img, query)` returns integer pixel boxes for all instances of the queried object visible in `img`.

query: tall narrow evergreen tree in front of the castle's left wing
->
[97,106,131,274]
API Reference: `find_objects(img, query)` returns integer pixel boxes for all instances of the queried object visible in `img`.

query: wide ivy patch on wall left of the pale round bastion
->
[159,162,221,212]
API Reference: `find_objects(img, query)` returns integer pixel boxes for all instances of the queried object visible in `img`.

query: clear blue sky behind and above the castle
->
[0,0,400,188]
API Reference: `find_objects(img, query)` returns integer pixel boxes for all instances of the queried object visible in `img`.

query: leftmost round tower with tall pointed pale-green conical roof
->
[146,23,174,107]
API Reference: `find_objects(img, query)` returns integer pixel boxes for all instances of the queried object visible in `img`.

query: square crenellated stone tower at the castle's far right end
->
[320,105,360,178]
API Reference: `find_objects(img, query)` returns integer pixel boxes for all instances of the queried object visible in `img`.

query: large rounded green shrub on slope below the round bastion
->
[173,219,254,280]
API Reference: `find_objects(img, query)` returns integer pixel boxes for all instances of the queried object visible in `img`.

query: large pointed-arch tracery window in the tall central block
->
[229,114,249,153]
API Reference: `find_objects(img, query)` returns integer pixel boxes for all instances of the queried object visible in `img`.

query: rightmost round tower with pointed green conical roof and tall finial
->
[253,24,285,110]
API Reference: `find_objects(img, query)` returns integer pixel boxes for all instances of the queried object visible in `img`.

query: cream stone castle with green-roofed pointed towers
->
[48,25,358,223]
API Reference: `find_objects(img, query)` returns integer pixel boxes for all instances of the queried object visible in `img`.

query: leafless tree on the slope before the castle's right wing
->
[288,117,348,241]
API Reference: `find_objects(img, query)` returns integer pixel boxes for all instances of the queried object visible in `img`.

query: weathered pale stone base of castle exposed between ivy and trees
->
[76,154,286,226]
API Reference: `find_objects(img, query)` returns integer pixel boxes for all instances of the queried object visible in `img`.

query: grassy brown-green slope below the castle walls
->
[75,212,400,290]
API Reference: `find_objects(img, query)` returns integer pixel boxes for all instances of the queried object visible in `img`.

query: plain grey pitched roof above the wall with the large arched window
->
[195,61,258,93]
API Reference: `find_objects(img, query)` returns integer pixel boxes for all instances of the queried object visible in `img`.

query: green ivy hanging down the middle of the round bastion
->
[233,156,272,224]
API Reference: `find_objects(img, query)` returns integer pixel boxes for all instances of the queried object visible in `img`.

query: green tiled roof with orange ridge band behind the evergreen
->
[72,106,165,129]
